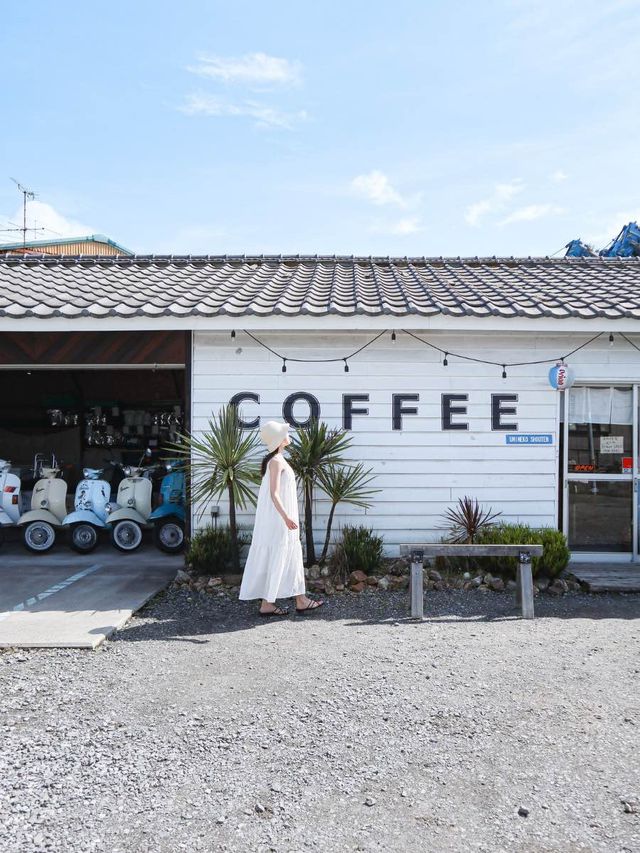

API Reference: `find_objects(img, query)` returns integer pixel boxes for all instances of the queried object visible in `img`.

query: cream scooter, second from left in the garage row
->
[18,456,67,554]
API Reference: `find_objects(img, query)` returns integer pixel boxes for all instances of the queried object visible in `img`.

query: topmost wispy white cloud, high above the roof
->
[187,53,301,87]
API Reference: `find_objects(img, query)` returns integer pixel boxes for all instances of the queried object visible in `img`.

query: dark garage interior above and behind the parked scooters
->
[0,332,190,510]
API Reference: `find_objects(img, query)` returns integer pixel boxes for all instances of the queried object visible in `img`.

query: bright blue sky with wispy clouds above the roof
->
[0,0,640,256]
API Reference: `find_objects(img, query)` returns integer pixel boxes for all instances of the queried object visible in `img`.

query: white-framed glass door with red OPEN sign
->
[564,385,638,560]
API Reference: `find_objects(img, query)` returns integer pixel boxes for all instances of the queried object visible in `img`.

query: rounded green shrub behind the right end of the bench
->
[477,522,569,578]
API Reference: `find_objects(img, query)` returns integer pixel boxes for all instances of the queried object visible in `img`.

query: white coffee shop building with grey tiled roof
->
[0,251,640,560]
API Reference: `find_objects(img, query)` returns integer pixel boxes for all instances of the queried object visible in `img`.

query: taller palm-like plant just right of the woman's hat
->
[289,418,351,566]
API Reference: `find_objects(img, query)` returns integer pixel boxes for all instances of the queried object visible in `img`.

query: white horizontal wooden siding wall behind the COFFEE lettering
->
[192,331,640,554]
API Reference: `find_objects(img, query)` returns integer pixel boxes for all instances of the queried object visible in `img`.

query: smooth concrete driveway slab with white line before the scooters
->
[0,543,183,649]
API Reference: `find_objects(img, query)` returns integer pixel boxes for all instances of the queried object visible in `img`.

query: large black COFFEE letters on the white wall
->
[229,391,518,432]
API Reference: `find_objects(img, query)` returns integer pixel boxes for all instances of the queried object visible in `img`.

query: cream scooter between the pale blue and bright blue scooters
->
[109,466,156,552]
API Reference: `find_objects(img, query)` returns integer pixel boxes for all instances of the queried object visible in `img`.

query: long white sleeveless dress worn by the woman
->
[239,460,305,601]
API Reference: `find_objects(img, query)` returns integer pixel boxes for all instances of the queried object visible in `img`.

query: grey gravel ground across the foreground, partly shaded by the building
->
[0,590,640,853]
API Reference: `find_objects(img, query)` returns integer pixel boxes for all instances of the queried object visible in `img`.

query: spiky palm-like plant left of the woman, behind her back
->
[168,404,260,572]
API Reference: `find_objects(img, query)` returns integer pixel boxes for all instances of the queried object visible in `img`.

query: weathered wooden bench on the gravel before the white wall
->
[400,542,542,619]
